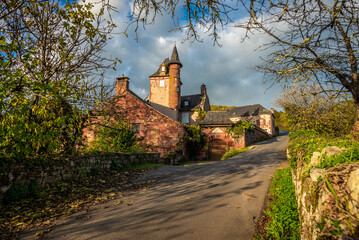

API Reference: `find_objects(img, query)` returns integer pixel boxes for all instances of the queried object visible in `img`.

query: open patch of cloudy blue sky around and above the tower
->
[97,0,280,109]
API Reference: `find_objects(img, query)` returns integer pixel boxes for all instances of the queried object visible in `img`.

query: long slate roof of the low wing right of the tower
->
[200,104,271,125]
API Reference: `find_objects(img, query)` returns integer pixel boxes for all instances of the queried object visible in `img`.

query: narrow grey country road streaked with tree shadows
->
[26,135,288,240]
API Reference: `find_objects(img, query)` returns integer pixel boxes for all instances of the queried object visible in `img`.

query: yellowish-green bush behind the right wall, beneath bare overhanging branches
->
[276,85,357,136]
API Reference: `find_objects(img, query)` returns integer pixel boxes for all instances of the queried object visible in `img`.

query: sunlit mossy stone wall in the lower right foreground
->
[292,147,359,239]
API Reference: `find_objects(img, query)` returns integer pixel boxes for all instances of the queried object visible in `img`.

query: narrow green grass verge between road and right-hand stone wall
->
[254,167,300,240]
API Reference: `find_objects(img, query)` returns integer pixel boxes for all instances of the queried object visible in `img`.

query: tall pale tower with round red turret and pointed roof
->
[149,45,182,120]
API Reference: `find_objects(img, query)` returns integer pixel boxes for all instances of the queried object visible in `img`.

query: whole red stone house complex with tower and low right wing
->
[85,46,274,161]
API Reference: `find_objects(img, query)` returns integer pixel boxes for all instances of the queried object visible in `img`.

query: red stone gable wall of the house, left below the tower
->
[84,91,185,157]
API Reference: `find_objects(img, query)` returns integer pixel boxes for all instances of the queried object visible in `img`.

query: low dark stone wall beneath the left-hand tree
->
[0,153,160,193]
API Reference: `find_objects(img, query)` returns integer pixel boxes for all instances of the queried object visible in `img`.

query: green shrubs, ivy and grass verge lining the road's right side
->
[256,85,359,239]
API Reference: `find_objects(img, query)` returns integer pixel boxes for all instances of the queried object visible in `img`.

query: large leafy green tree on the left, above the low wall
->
[0,0,115,161]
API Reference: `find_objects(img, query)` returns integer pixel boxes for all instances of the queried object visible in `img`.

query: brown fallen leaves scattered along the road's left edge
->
[0,169,155,239]
